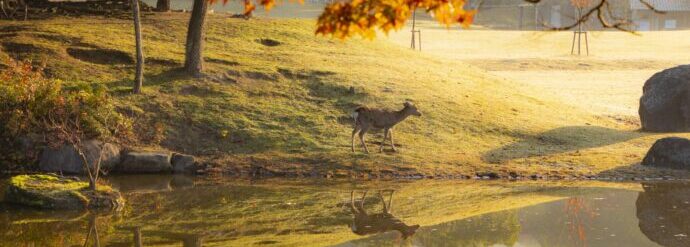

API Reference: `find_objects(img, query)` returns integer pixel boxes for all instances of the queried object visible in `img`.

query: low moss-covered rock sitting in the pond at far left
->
[4,174,124,210]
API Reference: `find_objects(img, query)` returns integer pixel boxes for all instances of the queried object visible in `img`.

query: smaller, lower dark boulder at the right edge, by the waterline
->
[642,137,690,169]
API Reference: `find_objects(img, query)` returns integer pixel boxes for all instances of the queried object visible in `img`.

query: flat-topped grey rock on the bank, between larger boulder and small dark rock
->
[115,152,172,173]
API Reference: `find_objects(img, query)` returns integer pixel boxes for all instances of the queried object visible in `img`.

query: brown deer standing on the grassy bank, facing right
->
[352,102,422,153]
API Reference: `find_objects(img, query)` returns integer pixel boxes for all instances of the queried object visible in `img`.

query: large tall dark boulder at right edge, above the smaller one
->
[639,65,690,132]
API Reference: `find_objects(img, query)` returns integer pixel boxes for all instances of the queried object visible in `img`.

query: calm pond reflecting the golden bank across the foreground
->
[0,175,690,246]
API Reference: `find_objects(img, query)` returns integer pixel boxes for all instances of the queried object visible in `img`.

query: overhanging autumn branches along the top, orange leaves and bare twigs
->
[228,0,661,39]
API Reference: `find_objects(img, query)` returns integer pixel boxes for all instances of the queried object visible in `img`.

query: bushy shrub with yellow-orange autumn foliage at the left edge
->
[0,61,131,169]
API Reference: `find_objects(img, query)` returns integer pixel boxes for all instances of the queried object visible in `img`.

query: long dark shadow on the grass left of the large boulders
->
[482,126,645,163]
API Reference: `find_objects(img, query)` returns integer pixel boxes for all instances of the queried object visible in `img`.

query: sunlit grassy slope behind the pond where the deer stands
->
[0,13,684,178]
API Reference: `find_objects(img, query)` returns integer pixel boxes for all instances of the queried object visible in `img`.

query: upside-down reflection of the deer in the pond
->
[350,191,419,239]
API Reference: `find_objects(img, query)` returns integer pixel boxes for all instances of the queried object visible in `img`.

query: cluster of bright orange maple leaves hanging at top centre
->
[316,0,475,39]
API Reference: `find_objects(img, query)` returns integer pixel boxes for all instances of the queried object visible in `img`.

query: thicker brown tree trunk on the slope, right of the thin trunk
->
[184,0,208,76]
